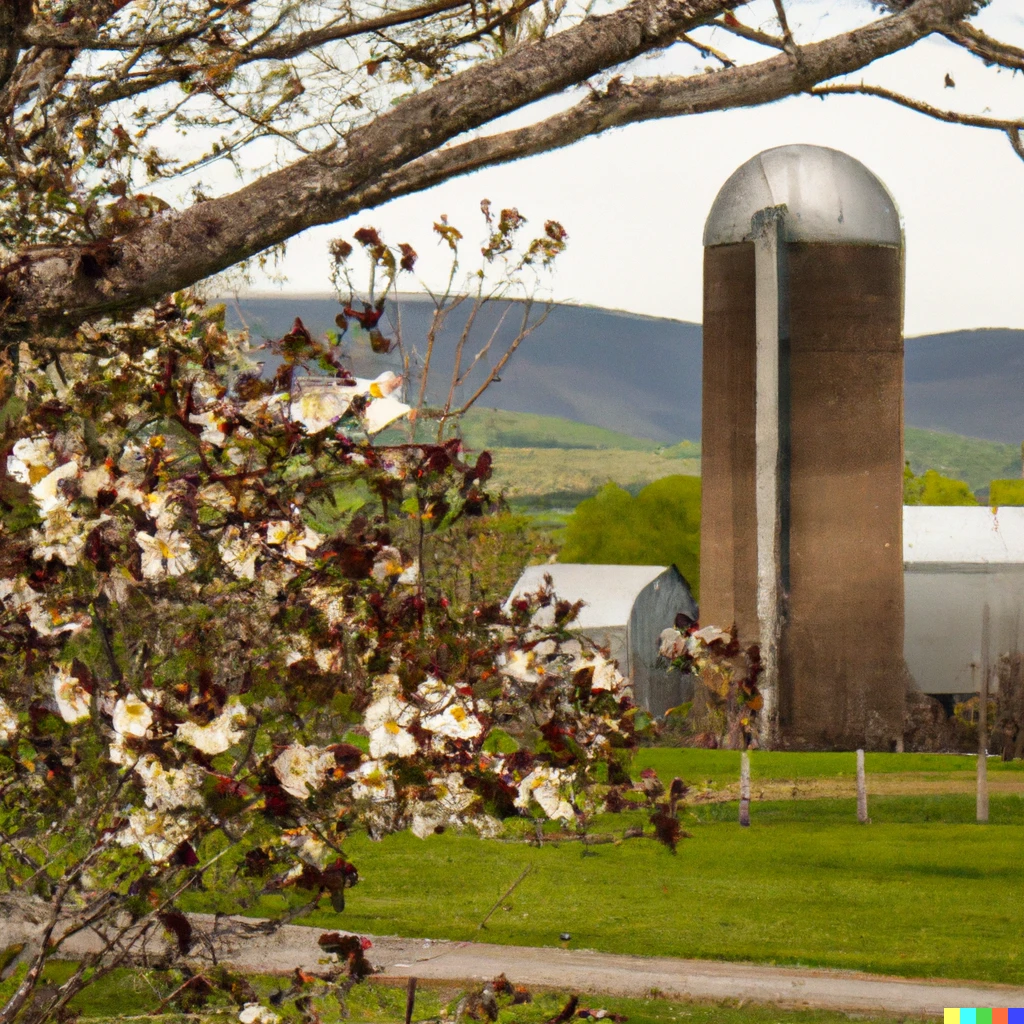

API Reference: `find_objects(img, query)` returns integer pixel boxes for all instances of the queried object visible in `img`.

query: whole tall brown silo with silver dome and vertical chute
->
[700,145,905,749]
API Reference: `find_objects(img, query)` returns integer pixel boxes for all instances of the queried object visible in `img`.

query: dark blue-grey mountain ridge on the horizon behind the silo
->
[228,296,1024,444]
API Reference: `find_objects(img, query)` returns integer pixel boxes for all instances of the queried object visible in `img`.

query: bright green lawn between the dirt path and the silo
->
[178,749,1024,984]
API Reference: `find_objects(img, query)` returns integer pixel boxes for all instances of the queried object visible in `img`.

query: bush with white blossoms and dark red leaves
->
[0,276,637,1022]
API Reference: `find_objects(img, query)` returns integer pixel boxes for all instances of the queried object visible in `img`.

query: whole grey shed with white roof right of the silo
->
[903,505,1024,697]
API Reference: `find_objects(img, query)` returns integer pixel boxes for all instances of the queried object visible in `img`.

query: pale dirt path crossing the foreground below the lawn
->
[29,915,1024,1016]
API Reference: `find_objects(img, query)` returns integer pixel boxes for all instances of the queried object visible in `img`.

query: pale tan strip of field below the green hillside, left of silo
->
[492,447,700,508]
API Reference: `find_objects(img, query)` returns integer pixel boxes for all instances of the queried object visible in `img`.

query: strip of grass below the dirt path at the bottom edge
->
[0,964,929,1024]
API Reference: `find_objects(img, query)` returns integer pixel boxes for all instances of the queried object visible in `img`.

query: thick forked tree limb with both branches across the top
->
[0,0,974,337]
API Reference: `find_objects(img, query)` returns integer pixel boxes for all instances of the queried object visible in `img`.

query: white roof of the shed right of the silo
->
[903,505,1024,567]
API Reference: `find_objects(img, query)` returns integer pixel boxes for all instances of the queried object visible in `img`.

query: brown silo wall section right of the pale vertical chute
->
[779,244,904,749]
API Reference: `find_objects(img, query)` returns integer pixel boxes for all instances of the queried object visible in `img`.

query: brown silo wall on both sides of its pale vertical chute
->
[700,243,904,749]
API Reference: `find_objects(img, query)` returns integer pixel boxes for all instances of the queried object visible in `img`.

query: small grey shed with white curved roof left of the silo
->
[511,562,697,716]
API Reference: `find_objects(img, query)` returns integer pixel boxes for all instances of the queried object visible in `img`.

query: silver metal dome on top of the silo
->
[703,145,903,247]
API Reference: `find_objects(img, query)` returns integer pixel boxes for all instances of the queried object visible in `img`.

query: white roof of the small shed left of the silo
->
[510,562,666,630]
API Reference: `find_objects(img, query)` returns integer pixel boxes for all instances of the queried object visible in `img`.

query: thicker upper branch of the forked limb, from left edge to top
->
[0,0,737,336]
